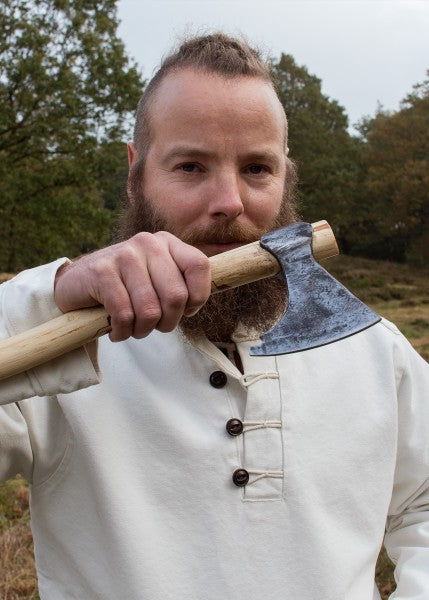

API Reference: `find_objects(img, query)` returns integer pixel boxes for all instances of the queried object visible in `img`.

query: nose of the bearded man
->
[209,173,244,221]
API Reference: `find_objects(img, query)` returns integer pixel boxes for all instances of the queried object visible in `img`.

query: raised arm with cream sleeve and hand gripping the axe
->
[0,232,210,403]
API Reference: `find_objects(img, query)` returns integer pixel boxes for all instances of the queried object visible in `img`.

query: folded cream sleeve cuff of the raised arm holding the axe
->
[0,258,99,404]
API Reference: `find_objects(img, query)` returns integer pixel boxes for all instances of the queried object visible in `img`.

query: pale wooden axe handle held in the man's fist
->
[0,221,338,380]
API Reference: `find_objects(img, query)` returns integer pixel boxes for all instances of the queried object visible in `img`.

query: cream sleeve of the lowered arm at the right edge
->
[385,341,429,600]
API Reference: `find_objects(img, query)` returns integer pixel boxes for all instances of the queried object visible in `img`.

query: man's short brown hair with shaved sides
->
[134,33,287,163]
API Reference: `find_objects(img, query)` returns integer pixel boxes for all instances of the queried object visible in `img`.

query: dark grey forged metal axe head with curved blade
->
[250,223,381,356]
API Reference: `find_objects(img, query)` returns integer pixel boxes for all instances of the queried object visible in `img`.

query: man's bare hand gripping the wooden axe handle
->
[55,231,210,342]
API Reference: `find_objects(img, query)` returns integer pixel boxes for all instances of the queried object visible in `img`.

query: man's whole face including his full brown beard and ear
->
[123,69,297,342]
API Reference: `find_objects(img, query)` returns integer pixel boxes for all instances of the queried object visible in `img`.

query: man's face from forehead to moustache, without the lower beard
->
[129,69,286,256]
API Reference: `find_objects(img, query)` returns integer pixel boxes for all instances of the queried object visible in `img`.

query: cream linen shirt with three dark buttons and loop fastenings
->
[0,260,429,600]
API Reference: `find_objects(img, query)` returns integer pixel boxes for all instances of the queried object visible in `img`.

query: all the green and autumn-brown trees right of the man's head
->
[273,54,429,264]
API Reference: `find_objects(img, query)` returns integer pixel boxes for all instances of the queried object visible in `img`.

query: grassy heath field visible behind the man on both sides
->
[0,256,429,600]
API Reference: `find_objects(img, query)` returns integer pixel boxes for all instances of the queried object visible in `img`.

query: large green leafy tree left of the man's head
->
[0,0,143,271]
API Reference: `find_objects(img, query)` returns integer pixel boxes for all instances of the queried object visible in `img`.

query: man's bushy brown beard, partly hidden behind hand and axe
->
[115,160,298,342]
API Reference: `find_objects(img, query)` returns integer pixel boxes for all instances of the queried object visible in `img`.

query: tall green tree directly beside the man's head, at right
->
[273,54,360,243]
